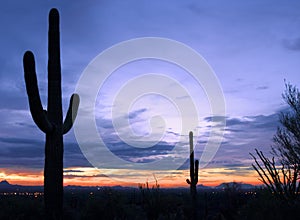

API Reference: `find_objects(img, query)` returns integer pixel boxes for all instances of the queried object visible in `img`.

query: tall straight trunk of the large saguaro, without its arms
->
[44,8,63,215]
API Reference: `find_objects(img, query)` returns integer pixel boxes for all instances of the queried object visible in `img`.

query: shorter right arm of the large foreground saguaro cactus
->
[63,94,79,134]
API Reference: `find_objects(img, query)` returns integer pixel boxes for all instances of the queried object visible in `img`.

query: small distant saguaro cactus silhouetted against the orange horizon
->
[186,132,199,197]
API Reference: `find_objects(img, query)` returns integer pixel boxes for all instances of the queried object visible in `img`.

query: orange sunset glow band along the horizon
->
[0,167,261,188]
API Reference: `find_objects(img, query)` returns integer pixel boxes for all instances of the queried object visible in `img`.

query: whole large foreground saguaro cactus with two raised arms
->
[23,9,79,219]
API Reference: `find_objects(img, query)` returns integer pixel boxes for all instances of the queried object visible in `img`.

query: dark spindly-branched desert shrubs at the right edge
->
[250,83,300,202]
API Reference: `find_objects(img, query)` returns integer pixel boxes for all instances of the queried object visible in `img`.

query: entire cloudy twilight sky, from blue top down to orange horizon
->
[0,0,300,186]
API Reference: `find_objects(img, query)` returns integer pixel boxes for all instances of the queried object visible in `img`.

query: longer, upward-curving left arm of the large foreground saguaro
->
[23,51,54,133]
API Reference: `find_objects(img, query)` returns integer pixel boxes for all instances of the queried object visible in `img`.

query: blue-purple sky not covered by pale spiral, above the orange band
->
[0,0,300,184]
